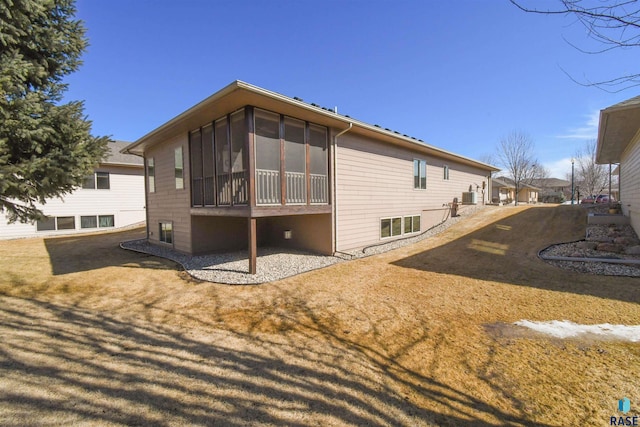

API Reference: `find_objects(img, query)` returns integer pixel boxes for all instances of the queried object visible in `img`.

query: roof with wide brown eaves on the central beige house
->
[123,80,499,171]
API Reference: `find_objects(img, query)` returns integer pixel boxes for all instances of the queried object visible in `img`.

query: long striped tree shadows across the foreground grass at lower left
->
[0,297,543,426]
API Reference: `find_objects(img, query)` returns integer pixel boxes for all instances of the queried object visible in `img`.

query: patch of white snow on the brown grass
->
[514,320,640,342]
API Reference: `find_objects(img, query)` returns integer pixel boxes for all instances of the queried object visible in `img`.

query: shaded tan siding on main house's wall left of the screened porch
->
[145,133,192,253]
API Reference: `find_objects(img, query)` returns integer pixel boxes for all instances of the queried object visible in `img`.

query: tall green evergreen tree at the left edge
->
[0,0,109,222]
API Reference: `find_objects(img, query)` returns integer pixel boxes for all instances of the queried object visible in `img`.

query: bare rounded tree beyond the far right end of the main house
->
[496,131,546,205]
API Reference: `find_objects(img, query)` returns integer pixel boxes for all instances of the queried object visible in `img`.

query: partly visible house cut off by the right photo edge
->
[596,96,640,234]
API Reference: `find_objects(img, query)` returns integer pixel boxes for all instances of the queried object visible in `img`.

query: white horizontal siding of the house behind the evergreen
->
[0,166,145,239]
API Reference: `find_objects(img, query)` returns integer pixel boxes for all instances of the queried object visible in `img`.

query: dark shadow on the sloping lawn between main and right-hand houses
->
[393,206,640,302]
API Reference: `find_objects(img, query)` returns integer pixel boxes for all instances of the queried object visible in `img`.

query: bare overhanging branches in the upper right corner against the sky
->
[509,0,640,92]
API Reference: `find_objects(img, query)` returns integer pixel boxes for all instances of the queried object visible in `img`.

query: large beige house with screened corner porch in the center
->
[126,81,497,272]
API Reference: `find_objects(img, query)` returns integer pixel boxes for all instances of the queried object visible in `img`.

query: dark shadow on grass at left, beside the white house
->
[44,228,176,275]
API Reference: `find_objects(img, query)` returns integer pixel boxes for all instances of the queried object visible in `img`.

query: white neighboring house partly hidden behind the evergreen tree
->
[0,142,145,239]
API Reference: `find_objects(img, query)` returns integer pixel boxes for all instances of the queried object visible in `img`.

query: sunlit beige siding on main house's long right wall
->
[336,133,489,251]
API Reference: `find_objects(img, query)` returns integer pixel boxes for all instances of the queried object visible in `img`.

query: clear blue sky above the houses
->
[66,0,637,178]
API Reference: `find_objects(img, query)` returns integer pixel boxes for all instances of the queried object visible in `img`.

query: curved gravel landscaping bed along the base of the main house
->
[120,206,484,285]
